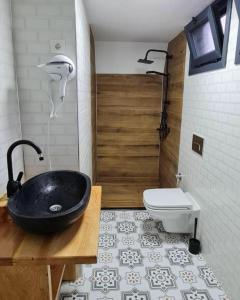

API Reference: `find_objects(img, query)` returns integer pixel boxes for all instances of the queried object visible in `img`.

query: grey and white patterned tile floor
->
[60,210,227,300]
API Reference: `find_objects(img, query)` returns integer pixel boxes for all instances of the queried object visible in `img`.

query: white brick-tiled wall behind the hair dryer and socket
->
[12,0,79,177]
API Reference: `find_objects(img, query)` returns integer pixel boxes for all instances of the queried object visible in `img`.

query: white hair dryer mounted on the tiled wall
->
[38,55,76,116]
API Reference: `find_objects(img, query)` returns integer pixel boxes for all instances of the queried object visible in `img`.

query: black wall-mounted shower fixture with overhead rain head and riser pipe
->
[138,49,172,141]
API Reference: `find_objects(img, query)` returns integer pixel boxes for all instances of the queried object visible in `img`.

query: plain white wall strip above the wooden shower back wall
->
[95,41,167,74]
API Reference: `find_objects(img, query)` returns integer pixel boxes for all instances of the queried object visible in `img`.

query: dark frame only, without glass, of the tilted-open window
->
[185,0,232,75]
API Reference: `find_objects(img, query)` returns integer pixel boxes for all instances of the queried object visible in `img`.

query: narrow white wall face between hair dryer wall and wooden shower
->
[75,0,92,177]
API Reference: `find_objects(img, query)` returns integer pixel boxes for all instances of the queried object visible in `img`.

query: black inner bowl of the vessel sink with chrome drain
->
[8,171,87,218]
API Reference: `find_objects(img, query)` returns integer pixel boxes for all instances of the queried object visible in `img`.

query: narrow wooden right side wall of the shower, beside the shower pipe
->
[160,33,186,188]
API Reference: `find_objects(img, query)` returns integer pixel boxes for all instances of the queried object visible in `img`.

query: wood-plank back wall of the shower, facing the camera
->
[96,74,162,207]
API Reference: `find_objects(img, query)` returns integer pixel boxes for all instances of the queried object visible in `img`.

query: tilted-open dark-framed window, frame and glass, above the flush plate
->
[185,0,232,75]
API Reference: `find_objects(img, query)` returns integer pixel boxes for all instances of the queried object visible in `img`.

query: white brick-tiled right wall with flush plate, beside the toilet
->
[179,2,240,300]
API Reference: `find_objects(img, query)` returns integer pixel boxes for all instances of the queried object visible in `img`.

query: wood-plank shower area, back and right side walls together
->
[94,34,186,208]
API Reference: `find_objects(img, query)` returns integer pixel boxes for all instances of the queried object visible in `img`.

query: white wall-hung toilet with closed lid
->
[143,188,200,233]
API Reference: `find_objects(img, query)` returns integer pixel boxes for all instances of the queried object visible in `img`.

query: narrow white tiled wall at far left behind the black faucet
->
[0,0,23,197]
